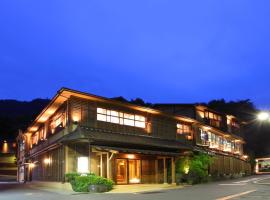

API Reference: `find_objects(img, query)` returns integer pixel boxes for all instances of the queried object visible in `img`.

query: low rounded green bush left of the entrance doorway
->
[66,173,114,192]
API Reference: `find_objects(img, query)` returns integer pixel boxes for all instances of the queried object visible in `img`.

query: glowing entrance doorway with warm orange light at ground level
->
[116,159,141,184]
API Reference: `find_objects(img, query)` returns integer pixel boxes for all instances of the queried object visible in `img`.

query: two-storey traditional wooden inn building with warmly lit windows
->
[17,88,250,184]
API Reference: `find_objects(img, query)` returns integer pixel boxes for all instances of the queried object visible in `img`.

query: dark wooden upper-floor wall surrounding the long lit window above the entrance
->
[70,97,189,141]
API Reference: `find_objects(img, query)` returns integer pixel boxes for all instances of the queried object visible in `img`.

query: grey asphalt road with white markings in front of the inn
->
[0,175,270,200]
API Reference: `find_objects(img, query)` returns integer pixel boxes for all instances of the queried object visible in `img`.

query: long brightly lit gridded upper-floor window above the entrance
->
[97,108,146,128]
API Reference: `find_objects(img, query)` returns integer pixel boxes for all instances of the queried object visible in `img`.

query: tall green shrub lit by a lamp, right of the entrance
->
[176,153,212,184]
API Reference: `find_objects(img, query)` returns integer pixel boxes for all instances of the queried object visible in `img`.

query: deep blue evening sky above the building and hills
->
[0,0,270,108]
